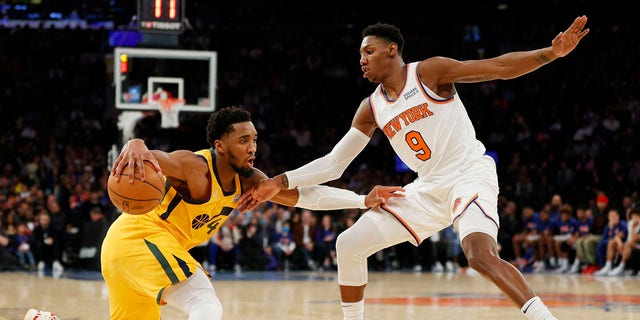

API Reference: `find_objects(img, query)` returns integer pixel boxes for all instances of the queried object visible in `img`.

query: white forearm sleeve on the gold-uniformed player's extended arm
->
[295,185,367,210]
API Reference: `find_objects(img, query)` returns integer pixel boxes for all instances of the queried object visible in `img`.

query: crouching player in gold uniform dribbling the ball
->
[101,107,402,320]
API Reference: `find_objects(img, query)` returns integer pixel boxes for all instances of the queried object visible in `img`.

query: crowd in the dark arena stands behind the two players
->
[0,1,640,275]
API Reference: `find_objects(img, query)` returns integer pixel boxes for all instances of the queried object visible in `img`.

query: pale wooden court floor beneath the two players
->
[0,271,640,320]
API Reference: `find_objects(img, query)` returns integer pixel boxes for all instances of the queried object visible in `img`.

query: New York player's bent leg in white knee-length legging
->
[336,211,410,320]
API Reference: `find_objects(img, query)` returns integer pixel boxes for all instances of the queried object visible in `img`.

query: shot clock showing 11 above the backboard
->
[138,0,185,33]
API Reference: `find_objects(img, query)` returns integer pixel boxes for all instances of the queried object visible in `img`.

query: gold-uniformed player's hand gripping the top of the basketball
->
[111,139,161,183]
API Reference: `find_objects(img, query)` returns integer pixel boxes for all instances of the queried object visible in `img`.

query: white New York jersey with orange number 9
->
[369,62,485,180]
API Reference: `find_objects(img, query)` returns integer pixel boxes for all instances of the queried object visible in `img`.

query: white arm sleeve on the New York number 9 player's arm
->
[285,127,371,188]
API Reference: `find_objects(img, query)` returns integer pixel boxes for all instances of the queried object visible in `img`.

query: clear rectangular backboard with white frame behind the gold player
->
[113,47,217,112]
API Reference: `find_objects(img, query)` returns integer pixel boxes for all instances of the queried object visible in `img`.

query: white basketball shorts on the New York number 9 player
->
[365,156,499,246]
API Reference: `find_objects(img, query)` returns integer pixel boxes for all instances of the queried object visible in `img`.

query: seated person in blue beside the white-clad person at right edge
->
[593,209,628,276]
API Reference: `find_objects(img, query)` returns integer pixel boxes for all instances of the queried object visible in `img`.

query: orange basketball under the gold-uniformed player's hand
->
[107,162,165,214]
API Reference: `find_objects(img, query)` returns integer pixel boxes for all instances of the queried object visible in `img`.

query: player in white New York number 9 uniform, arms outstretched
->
[244,16,589,320]
